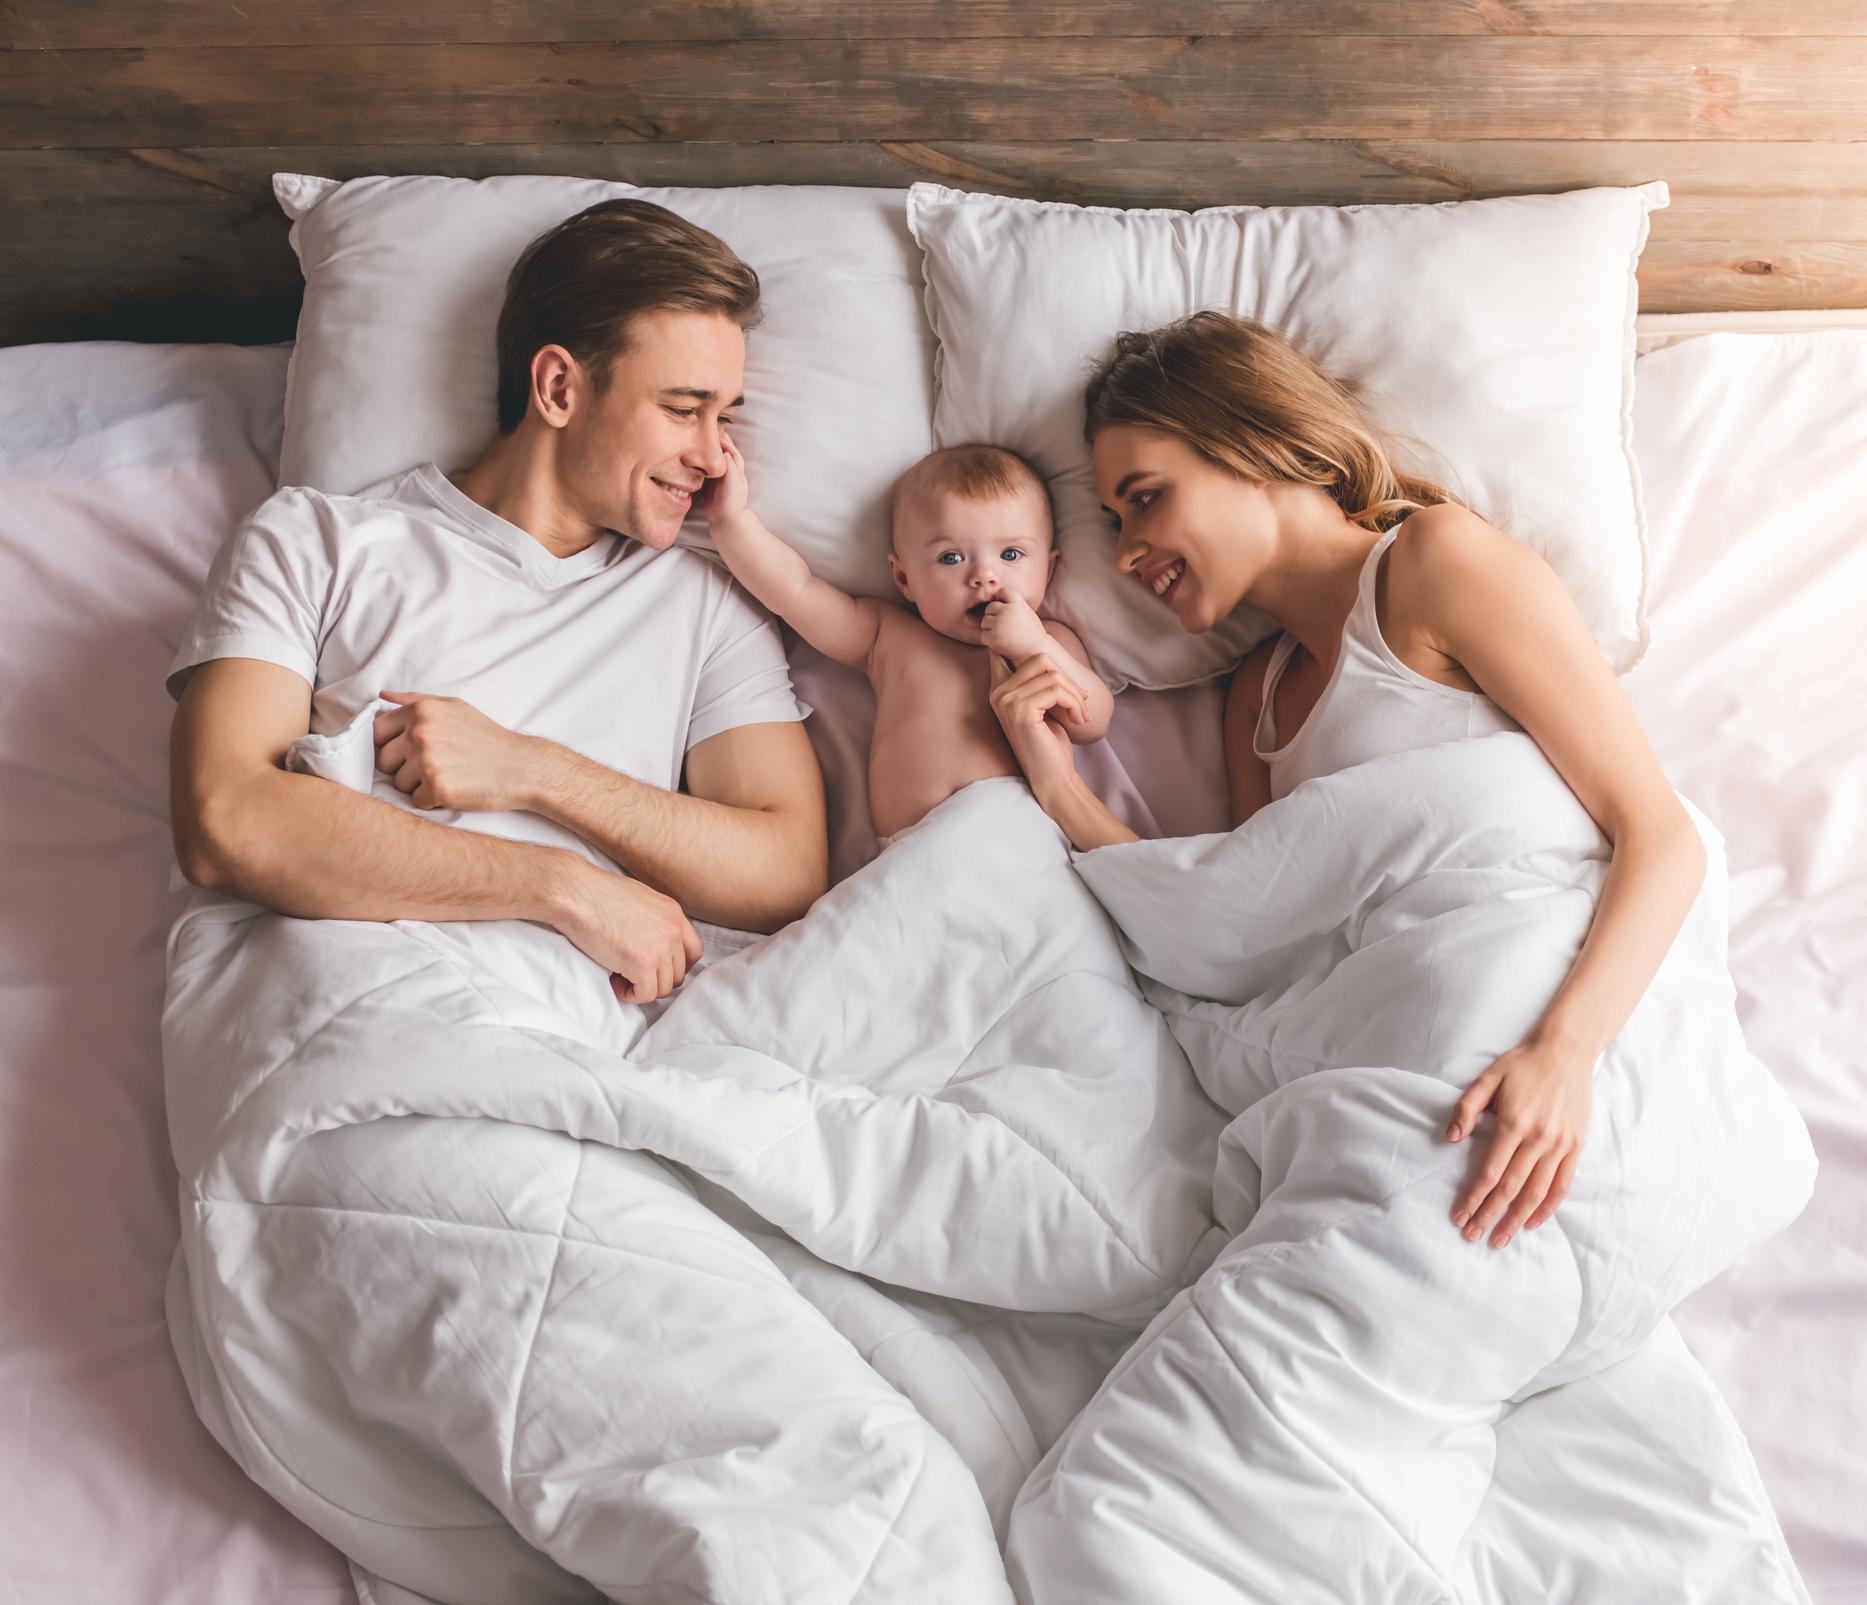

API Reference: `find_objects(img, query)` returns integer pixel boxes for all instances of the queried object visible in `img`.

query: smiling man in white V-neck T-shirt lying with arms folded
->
[170,200,827,1002]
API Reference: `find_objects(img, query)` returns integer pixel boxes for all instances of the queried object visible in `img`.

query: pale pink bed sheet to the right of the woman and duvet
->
[1626,330,1867,1605]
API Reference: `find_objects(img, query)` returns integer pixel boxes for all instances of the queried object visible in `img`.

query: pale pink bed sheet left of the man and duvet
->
[0,345,353,1605]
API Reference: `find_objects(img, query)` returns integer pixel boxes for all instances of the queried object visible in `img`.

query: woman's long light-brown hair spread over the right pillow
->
[1083,312,1456,530]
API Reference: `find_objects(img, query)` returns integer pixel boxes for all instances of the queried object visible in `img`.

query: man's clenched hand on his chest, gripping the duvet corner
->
[375,691,549,814]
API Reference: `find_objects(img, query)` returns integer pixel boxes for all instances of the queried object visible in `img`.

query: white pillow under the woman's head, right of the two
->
[907,183,1665,687]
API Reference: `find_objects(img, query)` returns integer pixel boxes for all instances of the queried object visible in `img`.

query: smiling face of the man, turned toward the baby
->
[558,310,745,549]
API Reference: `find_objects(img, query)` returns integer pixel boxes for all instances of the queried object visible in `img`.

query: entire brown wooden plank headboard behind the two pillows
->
[0,0,1867,343]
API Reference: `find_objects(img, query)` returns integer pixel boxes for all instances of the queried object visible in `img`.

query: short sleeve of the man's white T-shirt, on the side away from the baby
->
[168,489,332,700]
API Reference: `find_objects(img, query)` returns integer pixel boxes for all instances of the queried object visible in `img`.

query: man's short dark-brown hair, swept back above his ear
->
[497,200,758,435]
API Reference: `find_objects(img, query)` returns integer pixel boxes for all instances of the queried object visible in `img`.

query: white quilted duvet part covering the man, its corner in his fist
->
[164,753,1225,1605]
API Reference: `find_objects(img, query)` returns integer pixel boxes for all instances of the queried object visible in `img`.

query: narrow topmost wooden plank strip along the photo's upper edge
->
[14,0,1867,50]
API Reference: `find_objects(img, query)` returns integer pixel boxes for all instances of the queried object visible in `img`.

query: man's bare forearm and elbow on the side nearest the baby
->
[526,741,825,931]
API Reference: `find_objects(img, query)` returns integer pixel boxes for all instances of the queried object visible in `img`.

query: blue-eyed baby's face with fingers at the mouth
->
[889,489,1057,646]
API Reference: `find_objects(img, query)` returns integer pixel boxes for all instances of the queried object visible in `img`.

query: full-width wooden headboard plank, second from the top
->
[0,37,1867,149]
